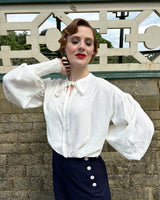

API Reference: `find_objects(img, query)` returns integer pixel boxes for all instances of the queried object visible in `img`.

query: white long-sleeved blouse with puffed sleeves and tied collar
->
[3,59,154,160]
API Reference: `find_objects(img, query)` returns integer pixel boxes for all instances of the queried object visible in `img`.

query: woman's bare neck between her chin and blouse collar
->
[68,67,89,81]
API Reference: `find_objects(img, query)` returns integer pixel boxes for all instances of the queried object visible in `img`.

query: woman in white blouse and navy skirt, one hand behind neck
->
[4,19,154,200]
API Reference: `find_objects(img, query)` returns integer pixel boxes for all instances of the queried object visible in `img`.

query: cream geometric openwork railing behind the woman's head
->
[0,2,160,74]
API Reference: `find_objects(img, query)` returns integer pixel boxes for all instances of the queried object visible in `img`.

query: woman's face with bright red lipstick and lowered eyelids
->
[65,26,94,67]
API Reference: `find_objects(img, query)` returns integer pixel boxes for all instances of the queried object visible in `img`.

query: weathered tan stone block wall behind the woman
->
[0,79,160,200]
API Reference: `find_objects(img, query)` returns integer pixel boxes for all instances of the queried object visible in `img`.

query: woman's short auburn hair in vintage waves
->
[59,18,98,61]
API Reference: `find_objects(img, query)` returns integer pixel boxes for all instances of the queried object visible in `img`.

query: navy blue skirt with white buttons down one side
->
[52,151,111,200]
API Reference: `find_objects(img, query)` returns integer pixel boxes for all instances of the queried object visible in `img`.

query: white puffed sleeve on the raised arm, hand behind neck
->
[3,58,61,108]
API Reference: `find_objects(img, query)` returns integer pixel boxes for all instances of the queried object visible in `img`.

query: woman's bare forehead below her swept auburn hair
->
[69,26,94,39]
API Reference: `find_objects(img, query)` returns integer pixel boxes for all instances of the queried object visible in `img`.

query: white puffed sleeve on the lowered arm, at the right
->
[106,86,154,160]
